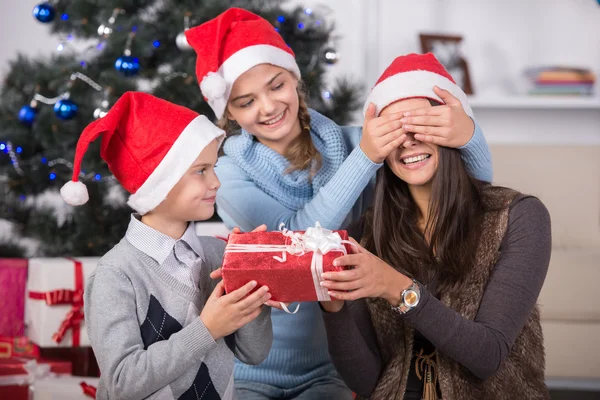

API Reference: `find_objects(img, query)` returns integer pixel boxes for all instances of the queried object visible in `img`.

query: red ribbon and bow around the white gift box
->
[29,258,83,347]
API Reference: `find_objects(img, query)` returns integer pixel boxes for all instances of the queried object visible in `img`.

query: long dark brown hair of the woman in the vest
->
[364,102,486,287]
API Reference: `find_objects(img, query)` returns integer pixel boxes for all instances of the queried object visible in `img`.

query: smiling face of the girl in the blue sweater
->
[226,64,300,146]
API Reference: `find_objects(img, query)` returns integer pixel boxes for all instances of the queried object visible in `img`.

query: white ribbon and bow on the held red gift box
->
[225,222,354,314]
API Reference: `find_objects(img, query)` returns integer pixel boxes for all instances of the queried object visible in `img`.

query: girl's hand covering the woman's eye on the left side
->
[360,103,406,164]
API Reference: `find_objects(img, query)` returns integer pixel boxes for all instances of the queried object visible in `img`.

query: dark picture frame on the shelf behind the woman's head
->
[419,33,473,94]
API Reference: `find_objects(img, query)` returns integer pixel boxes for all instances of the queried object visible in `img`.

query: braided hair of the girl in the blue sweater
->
[217,81,323,178]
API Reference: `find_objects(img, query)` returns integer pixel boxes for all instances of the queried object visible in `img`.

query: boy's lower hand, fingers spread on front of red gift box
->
[200,281,271,341]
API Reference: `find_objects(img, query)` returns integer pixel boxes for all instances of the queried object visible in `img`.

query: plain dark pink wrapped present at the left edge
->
[0,258,27,337]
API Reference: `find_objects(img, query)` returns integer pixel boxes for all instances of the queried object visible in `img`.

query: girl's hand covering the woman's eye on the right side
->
[401,86,475,148]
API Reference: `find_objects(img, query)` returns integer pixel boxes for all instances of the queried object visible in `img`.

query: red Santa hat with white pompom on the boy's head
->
[60,92,225,215]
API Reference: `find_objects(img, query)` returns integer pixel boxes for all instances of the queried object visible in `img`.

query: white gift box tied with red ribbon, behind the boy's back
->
[25,257,98,347]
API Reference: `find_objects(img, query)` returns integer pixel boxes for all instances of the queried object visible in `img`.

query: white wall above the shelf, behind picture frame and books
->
[374,0,600,94]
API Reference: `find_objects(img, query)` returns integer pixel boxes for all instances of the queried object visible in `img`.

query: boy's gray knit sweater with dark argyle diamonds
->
[84,233,273,400]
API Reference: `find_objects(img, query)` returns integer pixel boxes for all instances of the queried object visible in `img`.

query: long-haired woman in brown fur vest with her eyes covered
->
[322,54,551,400]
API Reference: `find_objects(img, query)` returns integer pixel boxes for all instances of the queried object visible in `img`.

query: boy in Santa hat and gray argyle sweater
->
[61,92,272,400]
